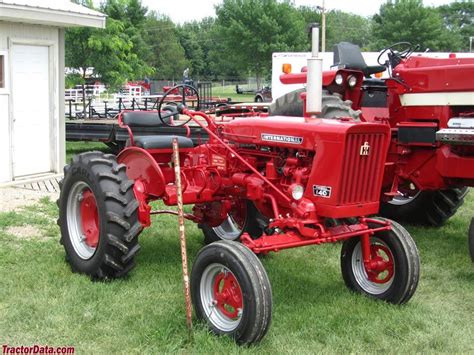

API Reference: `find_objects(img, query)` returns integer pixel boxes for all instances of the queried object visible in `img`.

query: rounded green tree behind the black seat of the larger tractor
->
[372,0,448,50]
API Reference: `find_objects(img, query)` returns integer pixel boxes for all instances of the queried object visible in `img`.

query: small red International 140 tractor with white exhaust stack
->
[59,28,419,344]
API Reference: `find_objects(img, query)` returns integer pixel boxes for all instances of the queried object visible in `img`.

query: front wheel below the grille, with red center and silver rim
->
[341,218,420,304]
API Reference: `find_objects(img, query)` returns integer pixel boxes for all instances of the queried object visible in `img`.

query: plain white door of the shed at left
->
[11,45,52,178]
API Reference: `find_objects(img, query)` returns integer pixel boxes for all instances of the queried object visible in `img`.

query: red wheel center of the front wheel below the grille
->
[367,244,394,284]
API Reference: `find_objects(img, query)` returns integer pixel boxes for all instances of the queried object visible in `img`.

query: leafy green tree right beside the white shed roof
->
[65,0,153,117]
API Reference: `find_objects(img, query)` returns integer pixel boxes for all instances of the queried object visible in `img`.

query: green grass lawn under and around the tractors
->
[0,144,474,354]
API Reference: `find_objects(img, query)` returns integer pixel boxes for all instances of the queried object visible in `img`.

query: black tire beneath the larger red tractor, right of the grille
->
[380,187,468,227]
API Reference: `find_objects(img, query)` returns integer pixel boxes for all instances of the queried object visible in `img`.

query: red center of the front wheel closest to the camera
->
[214,271,243,319]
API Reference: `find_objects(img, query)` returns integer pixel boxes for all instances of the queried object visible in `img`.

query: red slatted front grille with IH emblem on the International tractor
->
[339,133,385,205]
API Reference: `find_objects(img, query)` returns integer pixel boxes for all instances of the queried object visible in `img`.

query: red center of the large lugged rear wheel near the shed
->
[80,189,99,248]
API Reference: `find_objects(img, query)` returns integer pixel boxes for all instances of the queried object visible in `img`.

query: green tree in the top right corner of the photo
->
[437,0,474,52]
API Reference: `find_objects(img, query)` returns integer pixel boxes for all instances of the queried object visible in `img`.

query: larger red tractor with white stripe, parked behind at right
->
[276,42,474,260]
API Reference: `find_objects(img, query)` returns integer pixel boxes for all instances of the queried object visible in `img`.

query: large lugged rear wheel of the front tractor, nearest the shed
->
[58,152,142,280]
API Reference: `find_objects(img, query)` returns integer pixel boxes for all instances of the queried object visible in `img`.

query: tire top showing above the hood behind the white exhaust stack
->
[268,89,360,120]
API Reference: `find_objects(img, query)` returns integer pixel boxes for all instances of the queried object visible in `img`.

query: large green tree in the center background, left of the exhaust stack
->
[216,0,307,87]
